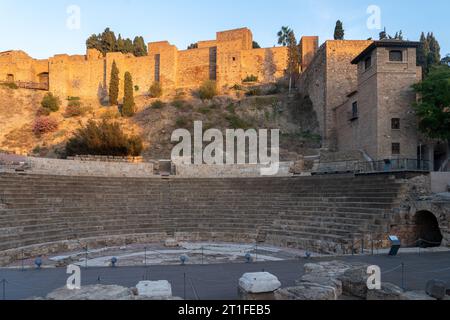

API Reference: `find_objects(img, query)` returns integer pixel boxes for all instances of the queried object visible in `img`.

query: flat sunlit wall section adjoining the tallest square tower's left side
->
[177,47,214,88]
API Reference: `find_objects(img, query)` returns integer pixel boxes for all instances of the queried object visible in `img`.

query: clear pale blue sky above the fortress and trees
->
[0,0,450,58]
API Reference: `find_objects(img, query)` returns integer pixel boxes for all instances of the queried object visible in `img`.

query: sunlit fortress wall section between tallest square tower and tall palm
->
[241,47,288,82]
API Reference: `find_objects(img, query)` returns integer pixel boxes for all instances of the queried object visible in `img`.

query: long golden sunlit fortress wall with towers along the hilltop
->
[0,28,296,99]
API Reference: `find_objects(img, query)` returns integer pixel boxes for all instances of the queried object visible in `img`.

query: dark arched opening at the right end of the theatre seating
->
[415,211,443,248]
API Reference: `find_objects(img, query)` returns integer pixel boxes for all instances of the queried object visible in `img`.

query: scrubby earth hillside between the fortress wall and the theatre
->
[0,86,320,160]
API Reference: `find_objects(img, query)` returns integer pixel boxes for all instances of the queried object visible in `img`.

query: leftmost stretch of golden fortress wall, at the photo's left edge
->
[0,51,48,82]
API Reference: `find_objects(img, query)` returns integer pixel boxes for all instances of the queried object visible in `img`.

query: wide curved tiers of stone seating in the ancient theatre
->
[0,173,402,262]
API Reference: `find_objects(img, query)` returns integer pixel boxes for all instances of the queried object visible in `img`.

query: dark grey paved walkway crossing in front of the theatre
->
[0,252,450,300]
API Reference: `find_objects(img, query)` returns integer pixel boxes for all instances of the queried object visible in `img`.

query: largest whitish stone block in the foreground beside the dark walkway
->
[239,272,281,293]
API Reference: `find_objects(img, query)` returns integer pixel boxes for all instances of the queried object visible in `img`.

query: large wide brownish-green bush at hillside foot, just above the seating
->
[66,120,143,156]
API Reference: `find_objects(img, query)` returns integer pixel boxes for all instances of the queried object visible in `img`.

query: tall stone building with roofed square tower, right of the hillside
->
[299,40,449,170]
